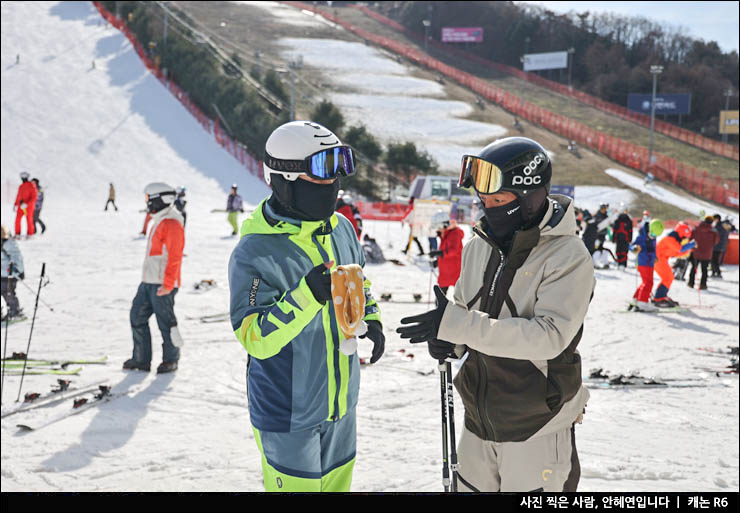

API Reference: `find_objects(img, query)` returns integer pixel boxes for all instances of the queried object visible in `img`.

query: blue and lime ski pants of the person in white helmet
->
[252,408,357,492]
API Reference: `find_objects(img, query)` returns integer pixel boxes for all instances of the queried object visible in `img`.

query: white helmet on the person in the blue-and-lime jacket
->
[262,121,354,185]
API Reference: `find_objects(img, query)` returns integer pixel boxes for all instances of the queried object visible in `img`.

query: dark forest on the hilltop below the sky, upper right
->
[382,1,738,140]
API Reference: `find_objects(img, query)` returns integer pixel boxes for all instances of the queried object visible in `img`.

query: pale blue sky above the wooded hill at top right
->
[517,1,740,52]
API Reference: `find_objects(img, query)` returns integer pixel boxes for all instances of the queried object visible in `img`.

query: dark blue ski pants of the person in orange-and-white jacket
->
[130,283,180,364]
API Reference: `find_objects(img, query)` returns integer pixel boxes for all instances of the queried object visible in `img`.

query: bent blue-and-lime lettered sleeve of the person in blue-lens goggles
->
[229,246,324,360]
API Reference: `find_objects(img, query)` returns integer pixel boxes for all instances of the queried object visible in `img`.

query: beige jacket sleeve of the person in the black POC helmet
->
[437,240,595,360]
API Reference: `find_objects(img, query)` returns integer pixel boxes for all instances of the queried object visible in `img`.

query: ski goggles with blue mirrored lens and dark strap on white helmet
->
[265,146,355,181]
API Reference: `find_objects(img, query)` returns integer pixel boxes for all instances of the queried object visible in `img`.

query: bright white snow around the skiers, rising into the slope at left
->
[0,2,739,492]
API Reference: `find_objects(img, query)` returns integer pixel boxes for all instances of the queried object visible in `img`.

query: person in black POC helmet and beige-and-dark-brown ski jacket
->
[397,137,595,492]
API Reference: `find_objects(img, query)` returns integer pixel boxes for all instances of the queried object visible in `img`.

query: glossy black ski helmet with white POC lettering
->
[463,137,552,219]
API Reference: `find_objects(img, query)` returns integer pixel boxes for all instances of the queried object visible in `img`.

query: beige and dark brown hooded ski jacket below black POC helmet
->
[437,195,595,442]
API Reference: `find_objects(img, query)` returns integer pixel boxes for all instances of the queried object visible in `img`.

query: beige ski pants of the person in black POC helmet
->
[457,426,581,492]
